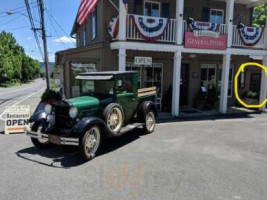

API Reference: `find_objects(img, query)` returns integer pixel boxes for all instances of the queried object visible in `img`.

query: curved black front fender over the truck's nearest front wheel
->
[71,117,111,137]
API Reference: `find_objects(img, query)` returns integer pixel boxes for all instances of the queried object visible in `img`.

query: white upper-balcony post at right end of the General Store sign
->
[226,0,235,48]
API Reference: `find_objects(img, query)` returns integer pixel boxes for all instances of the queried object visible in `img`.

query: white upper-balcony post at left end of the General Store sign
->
[176,0,184,45]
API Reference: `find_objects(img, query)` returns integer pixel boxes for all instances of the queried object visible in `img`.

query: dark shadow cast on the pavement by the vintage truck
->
[16,129,147,169]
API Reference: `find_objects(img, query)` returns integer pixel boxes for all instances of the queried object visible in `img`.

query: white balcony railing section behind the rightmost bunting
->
[232,25,267,49]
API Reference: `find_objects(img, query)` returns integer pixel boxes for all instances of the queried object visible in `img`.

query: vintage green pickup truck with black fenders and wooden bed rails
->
[26,71,157,160]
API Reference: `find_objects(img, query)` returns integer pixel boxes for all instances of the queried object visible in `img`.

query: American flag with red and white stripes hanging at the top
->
[77,0,99,25]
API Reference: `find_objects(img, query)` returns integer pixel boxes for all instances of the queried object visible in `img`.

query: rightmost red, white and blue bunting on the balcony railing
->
[237,23,263,46]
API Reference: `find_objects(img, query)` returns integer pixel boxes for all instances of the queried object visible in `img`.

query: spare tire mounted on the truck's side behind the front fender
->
[103,103,124,136]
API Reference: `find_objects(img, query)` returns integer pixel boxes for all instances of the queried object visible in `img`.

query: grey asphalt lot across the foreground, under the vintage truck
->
[0,115,267,200]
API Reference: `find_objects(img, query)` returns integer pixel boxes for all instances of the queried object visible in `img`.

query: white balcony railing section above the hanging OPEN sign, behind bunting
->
[126,14,177,43]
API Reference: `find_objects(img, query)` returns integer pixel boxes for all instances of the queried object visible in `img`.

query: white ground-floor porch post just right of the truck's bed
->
[172,50,182,117]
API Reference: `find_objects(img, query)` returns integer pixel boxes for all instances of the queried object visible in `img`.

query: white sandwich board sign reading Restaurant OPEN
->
[5,105,31,135]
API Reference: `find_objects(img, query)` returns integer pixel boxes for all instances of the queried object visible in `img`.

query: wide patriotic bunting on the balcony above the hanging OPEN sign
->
[131,15,169,41]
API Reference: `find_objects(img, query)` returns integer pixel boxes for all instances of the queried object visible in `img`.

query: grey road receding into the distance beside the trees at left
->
[0,79,45,120]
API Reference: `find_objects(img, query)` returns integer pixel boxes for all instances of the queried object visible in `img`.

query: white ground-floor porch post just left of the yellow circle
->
[220,54,231,114]
